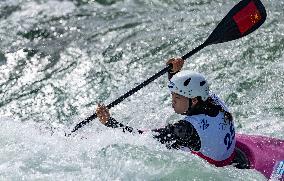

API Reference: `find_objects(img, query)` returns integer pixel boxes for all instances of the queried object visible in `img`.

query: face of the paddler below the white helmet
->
[172,92,189,114]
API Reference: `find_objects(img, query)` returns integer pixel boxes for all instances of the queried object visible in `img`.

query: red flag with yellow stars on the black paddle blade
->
[233,1,261,34]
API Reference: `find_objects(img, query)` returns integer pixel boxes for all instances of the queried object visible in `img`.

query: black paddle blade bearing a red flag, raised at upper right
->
[205,0,266,45]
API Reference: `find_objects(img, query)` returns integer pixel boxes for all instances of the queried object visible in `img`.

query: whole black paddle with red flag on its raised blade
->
[68,0,266,135]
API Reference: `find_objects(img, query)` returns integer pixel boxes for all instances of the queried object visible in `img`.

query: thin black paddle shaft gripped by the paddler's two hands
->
[71,43,207,133]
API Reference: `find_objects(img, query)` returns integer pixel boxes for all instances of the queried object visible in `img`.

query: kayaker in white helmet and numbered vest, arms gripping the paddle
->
[96,58,246,167]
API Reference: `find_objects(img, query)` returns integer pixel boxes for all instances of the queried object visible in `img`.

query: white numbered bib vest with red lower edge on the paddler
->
[184,95,236,166]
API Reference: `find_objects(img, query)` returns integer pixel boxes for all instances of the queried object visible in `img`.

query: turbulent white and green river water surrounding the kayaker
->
[0,0,284,180]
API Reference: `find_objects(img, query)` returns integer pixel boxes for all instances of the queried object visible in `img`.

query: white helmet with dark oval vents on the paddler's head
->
[168,70,209,101]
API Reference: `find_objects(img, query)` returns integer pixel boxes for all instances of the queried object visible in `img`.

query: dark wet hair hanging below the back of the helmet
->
[185,96,233,122]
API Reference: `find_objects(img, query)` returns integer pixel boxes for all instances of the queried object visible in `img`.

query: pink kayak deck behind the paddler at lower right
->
[236,134,284,181]
